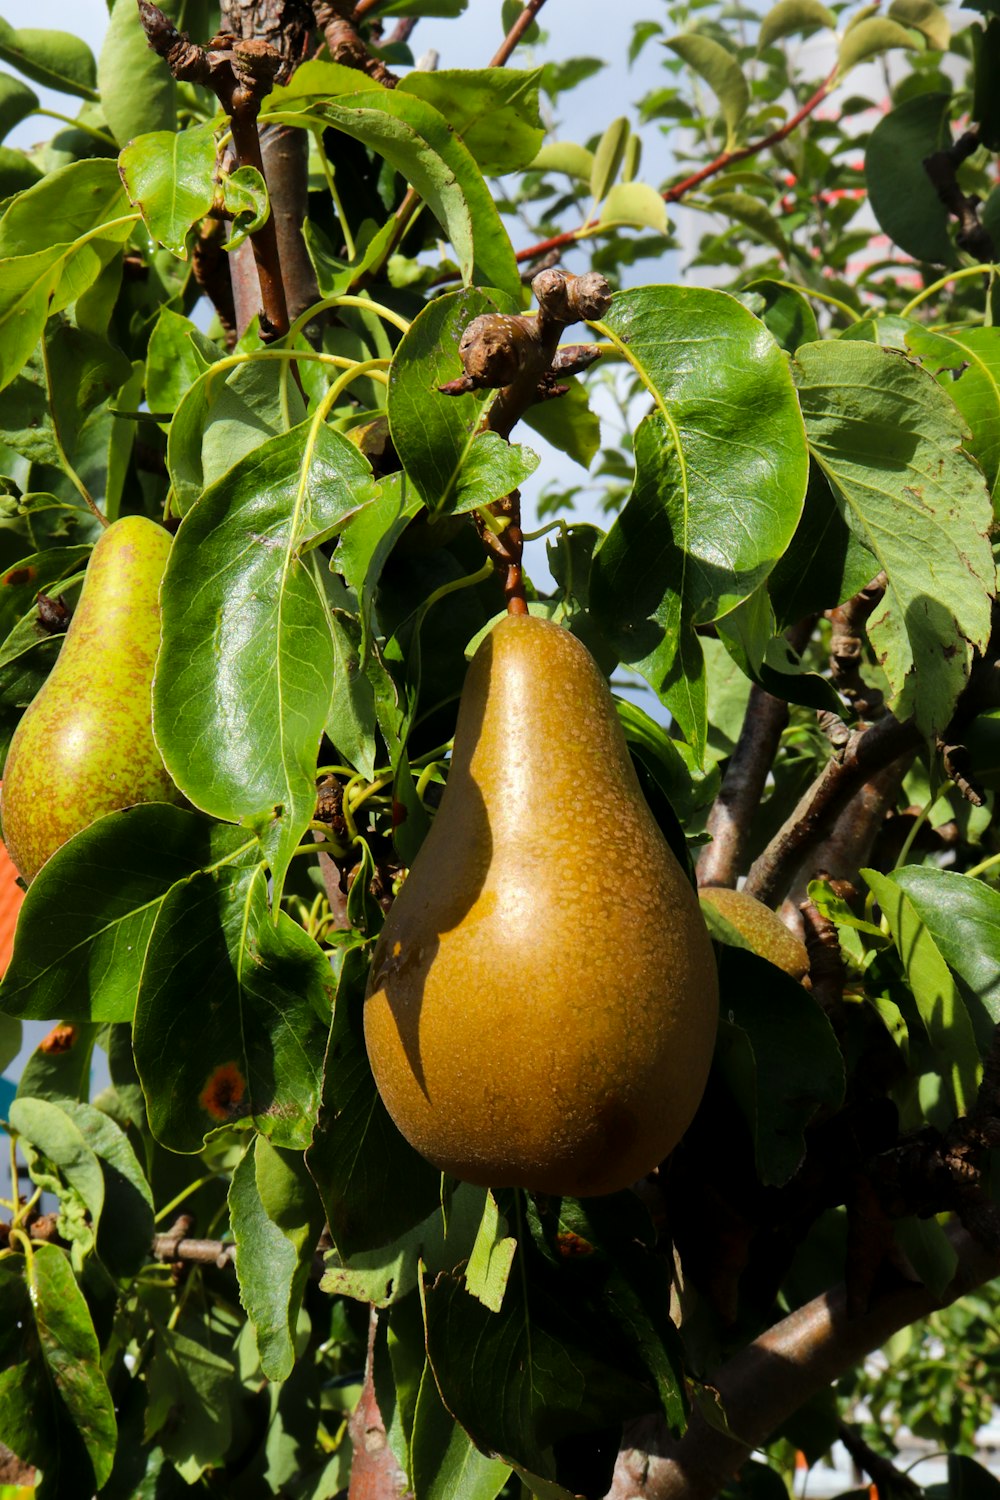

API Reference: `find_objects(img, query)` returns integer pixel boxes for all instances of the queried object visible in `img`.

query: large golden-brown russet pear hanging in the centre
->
[364,615,718,1197]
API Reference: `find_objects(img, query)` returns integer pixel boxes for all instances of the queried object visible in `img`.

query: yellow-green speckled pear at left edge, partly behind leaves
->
[0,516,178,881]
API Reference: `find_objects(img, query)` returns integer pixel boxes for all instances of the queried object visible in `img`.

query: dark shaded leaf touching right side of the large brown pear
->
[715,947,844,1187]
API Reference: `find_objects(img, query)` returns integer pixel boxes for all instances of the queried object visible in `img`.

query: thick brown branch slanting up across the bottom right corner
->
[607,1230,1000,1500]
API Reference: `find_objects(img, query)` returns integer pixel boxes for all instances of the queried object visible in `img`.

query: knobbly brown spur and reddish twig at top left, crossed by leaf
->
[138,0,288,339]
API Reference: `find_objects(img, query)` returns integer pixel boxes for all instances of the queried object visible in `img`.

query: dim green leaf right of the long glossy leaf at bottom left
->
[144,1328,235,1488]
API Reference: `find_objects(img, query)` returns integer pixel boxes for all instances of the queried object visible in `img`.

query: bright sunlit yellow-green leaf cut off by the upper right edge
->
[906,326,1000,515]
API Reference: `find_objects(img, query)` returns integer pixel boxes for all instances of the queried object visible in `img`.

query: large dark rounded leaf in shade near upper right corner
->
[852,93,958,267]
